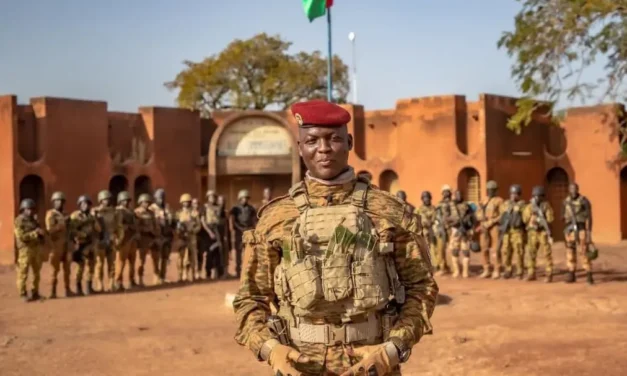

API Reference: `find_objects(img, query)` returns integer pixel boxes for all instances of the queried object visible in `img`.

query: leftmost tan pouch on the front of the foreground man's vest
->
[285,255,323,310]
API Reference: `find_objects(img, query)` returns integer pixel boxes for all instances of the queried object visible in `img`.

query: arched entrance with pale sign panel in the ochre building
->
[208,111,301,208]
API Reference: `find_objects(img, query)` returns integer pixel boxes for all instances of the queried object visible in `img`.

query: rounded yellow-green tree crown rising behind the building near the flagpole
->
[165,33,349,116]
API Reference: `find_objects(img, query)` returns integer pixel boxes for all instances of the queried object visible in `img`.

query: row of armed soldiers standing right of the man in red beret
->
[397,181,598,284]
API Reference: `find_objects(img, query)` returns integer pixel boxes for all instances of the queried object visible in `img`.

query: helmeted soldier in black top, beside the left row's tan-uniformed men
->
[229,189,257,278]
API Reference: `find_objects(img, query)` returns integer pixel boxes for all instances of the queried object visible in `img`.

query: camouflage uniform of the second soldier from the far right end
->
[523,192,554,282]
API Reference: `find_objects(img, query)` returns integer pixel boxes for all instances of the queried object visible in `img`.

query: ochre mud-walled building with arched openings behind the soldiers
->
[0,94,627,263]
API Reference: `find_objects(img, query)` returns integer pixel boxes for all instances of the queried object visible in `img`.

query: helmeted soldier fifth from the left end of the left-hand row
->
[113,191,139,292]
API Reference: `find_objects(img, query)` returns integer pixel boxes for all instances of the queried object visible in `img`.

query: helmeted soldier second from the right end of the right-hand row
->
[523,185,554,283]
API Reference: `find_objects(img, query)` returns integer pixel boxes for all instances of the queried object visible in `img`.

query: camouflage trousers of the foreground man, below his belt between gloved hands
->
[292,344,401,376]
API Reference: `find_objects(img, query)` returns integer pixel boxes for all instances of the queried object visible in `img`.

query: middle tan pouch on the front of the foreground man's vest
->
[322,253,353,302]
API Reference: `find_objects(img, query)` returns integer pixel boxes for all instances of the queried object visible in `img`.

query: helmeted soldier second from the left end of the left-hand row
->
[45,192,72,299]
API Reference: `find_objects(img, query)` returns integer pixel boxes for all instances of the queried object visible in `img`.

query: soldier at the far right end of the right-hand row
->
[562,183,597,285]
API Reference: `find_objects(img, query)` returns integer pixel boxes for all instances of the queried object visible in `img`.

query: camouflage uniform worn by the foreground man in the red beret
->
[233,175,438,375]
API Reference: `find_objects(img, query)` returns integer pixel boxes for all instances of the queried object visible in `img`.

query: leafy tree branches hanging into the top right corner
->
[498,0,627,142]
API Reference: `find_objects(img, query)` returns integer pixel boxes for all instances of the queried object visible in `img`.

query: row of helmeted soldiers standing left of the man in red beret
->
[14,188,264,301]
